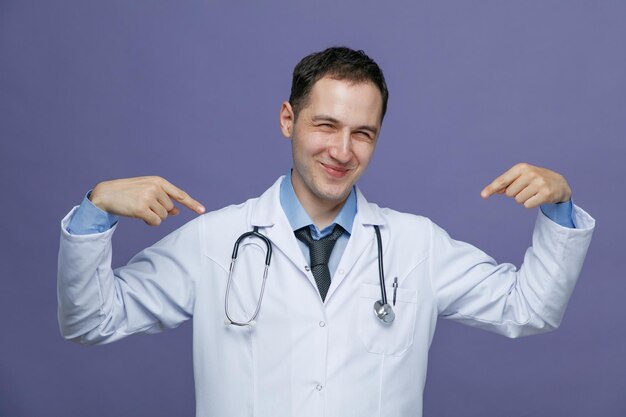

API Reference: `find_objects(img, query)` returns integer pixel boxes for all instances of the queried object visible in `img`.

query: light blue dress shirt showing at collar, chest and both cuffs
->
[67,171,576,276]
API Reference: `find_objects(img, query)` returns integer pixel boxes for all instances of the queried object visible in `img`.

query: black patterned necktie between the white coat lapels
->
[295,225,343,301]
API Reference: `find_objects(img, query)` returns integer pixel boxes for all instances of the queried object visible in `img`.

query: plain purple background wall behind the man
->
[0,0,626,417]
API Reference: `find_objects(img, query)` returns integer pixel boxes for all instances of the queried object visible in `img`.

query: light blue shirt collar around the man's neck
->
[280,170,357,234]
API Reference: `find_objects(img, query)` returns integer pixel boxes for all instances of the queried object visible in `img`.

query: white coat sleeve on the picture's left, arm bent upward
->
[57,209,201,344]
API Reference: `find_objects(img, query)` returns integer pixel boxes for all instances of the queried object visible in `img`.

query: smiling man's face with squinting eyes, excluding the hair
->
[280,77,382,208]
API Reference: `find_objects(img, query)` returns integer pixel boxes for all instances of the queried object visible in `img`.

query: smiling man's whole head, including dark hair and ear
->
[280,48,387,216]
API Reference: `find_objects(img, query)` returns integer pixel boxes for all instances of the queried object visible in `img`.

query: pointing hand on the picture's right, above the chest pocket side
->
[480,163,572,209]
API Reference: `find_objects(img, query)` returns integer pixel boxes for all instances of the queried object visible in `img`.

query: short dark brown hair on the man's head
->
[289,47,389,123]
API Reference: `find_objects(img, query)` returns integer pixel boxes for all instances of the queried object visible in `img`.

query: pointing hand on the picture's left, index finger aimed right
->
[89,177,205,226]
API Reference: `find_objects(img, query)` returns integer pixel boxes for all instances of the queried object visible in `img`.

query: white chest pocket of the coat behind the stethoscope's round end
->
[356,284,417,356]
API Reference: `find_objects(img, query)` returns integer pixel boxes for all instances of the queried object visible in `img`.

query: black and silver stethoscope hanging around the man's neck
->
[224,225,397,326]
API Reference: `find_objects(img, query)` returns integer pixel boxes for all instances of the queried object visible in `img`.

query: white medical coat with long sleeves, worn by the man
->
[58,179,594,417]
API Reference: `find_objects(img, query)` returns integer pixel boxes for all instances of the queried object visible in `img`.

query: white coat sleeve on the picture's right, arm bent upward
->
[430,206,595,337]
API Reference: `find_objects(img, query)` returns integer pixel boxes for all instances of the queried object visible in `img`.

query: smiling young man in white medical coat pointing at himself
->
[58,48,594,417]
